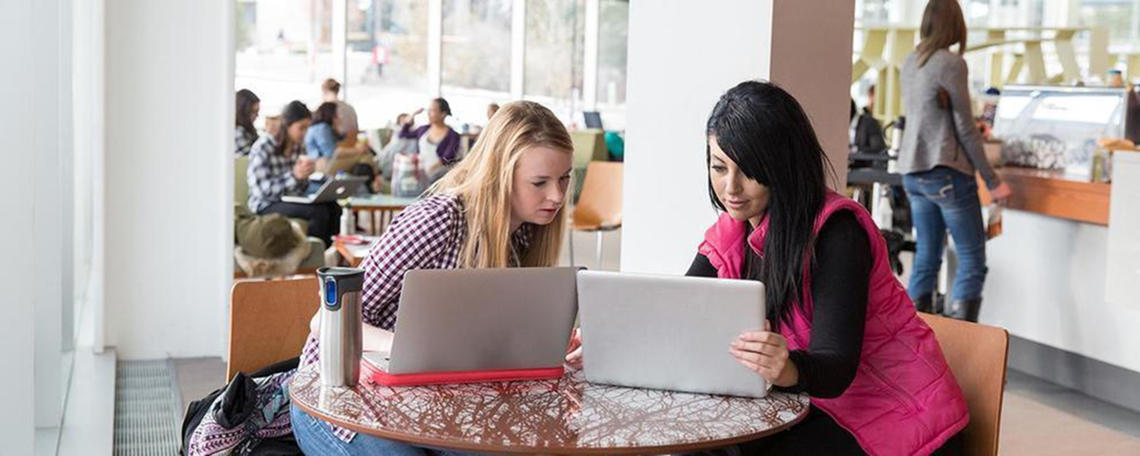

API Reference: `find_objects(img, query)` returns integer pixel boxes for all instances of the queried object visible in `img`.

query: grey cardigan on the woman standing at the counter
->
[898,49,1001,188]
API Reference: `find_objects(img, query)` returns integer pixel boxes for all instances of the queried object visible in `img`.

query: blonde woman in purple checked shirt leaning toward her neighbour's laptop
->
[292,101,573,455]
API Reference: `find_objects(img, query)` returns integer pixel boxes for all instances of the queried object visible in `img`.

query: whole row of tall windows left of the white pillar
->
[235,0,629,129]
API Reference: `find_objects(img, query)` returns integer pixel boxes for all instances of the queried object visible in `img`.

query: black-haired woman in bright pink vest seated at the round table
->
[689,81,969,455]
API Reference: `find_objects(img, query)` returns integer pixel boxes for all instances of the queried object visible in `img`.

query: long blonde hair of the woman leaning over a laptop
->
[428,101,573,268]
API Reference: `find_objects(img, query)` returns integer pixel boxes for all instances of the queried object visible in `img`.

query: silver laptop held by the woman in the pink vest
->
[578,271,767,397]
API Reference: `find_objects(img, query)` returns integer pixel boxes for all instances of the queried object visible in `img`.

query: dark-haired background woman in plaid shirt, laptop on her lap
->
[245,101,341,241]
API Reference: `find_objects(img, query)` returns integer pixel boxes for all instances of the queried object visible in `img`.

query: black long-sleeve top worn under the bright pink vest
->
[686,211,871,398]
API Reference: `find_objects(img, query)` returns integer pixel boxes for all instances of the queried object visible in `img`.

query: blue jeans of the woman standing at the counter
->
[903,166,986,300]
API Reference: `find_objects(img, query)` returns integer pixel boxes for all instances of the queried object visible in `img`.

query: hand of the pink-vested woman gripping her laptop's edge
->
[728,321,799,386]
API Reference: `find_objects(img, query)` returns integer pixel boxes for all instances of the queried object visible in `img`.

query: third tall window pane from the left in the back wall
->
[440,0,512,124]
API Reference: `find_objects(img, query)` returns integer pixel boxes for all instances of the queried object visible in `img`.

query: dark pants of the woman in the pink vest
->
[694,407,962,456]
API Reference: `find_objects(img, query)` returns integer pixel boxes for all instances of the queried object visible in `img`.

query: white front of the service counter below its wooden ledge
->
[978,211,1140,372]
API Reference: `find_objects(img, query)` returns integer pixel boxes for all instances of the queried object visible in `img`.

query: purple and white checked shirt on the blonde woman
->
[301,195,531,442]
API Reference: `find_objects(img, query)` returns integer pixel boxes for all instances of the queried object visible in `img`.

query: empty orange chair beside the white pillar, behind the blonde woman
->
[570,162,621,268]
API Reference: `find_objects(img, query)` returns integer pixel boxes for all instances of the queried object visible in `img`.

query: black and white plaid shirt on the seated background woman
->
[245,135,309,213]
